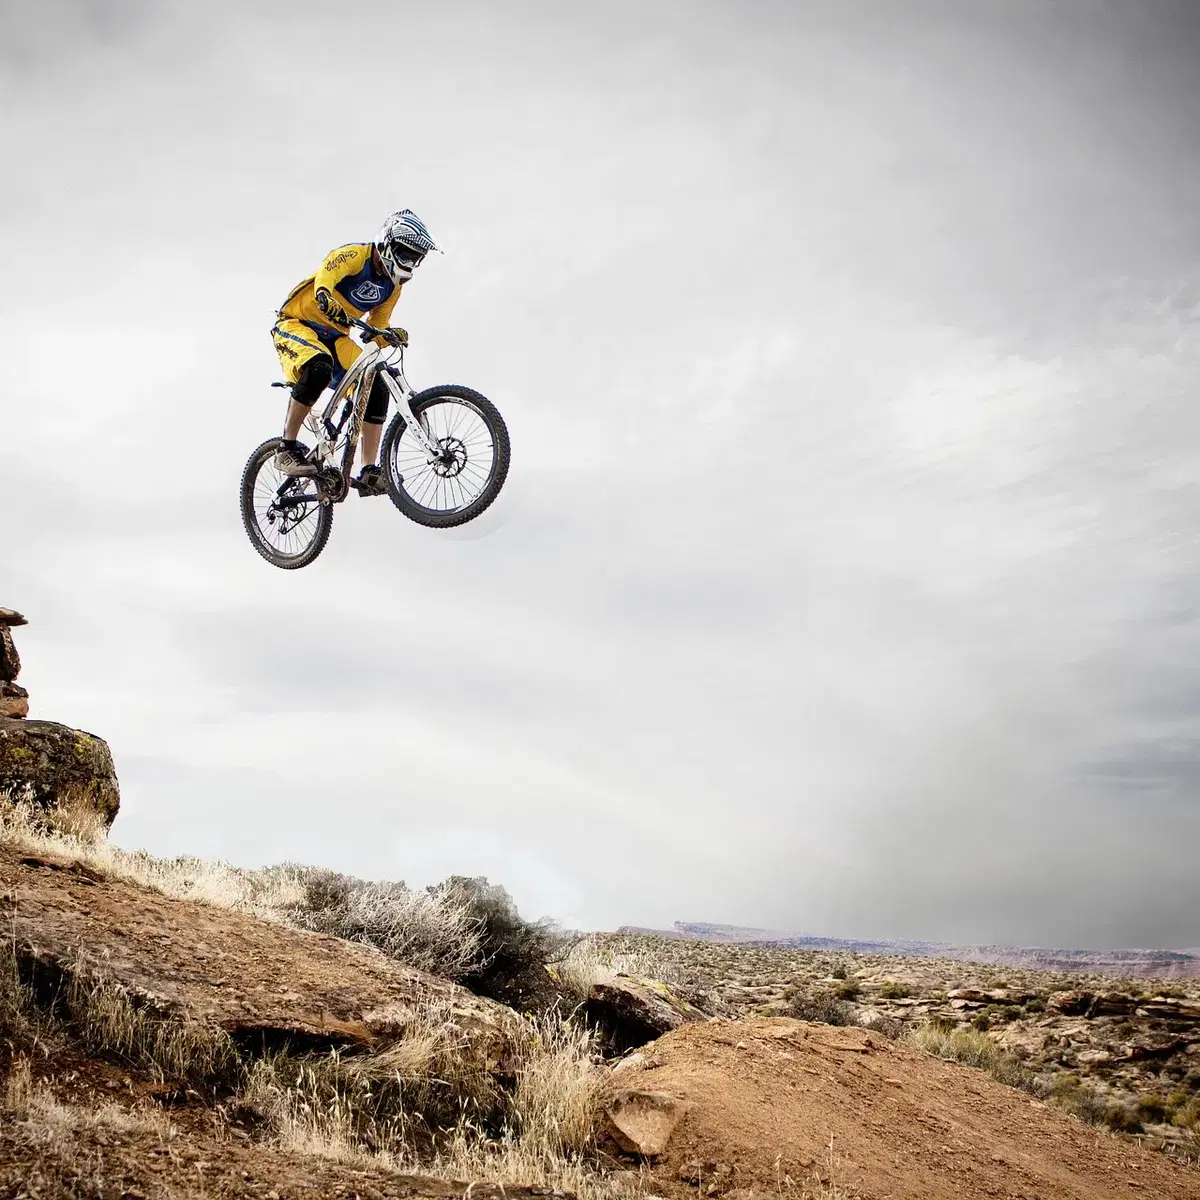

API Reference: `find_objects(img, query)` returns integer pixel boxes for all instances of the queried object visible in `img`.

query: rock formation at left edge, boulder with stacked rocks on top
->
[0,607,121,829]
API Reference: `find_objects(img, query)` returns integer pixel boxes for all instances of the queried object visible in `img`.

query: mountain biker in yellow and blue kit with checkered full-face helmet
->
[271,209,438,496]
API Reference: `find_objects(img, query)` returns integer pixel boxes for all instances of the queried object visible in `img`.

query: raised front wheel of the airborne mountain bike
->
[380,384,510,529]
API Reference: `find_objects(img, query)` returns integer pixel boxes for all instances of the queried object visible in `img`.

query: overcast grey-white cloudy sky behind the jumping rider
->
[0,0,1200,947]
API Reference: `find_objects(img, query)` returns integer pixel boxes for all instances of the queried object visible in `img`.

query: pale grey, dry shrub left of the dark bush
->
[282,868,484,982]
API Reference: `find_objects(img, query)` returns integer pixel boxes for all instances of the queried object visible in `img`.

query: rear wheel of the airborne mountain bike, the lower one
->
[241,438,334,571]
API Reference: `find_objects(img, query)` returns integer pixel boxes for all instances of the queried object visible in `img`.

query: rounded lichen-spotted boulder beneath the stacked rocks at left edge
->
[0,716,121,828]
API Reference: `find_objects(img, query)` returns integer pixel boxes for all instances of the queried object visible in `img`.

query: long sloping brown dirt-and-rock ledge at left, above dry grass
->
[0,846,516,1070]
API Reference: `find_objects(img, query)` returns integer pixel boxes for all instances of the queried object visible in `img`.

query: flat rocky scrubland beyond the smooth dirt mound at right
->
[590,934,1200,1154]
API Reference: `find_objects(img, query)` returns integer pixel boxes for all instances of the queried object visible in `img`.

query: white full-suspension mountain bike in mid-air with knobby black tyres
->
[241,319,510,570]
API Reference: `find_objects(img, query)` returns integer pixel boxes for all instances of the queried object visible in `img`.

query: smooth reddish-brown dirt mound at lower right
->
[612,1018,1200,1200]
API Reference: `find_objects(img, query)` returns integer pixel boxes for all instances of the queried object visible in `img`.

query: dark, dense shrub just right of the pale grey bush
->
[444,875,568,1012]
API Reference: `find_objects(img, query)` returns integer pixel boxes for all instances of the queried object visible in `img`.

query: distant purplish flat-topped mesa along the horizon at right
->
[619,920,1200,979]
